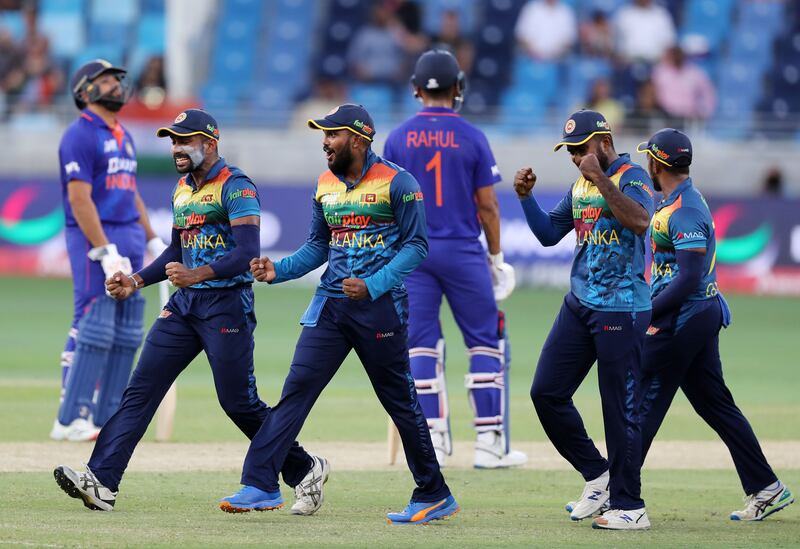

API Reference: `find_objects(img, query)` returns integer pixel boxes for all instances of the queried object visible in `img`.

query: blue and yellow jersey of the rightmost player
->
[650,178,719,301]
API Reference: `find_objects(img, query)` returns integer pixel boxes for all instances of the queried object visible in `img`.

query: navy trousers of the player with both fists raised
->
[531,293,650,509]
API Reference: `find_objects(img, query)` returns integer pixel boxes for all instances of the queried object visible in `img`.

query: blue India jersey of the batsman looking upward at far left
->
[58,110,139,227]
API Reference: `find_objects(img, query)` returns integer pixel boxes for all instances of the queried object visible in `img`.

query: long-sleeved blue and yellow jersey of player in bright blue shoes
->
[275,151,428,300]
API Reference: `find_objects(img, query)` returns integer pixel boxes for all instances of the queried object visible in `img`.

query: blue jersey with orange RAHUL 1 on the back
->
[383,107,501,238]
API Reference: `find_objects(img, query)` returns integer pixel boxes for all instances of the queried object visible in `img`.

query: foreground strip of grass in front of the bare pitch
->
[0,471,800,549]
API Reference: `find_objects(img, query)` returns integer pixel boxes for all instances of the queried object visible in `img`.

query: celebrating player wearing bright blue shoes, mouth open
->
[220,104,459,524]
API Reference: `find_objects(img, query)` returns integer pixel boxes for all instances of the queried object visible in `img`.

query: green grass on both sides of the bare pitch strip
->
[0,279,800,548]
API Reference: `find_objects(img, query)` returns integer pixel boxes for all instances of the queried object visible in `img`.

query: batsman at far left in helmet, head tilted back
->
[50,59,165,441]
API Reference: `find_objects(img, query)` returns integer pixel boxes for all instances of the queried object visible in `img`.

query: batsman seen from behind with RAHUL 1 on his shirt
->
[384,50,528,469]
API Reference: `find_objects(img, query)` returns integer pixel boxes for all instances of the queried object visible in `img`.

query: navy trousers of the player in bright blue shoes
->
[242,293,450,502]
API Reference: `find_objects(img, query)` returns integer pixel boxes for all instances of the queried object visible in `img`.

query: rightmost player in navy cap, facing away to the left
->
[637,128,794,521]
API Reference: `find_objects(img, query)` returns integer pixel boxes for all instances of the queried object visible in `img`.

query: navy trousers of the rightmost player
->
[640,299,778,494]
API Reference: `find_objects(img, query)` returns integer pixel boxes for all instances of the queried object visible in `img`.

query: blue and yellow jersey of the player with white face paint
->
[172,158,261,288]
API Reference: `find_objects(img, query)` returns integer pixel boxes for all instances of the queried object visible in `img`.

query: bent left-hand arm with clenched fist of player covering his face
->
[514,168,574,246]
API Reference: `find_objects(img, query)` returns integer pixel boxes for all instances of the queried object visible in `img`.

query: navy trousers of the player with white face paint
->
[89,287,313,490]
